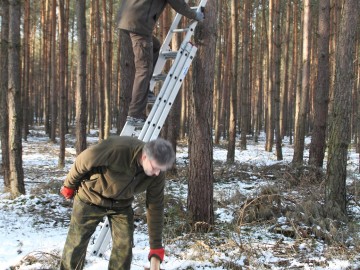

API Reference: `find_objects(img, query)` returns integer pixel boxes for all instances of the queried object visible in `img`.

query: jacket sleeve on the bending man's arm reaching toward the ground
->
[146,173,165,249]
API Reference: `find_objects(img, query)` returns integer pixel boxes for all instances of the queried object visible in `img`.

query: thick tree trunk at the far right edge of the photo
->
[325,0,360,215]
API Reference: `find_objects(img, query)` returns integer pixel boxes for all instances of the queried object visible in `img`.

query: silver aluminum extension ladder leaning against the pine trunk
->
[92,0,207,257]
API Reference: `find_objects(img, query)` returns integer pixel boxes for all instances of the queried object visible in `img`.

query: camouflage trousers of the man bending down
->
[60,196,134,270]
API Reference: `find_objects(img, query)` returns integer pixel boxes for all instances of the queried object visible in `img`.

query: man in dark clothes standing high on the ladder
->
[118,0,204,125]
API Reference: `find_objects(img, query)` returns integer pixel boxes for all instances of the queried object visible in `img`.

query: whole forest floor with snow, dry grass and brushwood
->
[0,128,360,270]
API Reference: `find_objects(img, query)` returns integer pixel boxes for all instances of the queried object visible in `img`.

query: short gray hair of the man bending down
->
[144,138,175,169]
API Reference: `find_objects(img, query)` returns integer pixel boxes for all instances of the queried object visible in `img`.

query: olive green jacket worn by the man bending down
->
[64,136,165,248]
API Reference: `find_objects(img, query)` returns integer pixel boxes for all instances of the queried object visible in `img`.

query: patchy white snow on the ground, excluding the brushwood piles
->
[0,130,360,270]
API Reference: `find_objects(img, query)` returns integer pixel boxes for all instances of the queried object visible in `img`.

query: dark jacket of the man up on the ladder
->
[118,0,196,36]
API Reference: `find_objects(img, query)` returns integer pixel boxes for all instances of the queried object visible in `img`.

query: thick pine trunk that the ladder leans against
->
[187,1,217,226]
